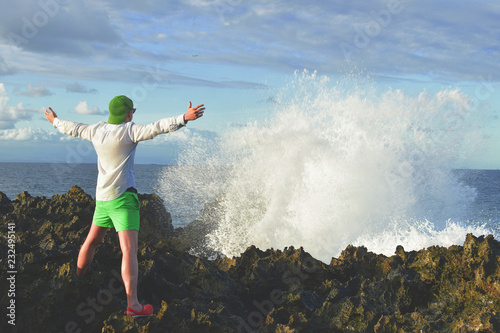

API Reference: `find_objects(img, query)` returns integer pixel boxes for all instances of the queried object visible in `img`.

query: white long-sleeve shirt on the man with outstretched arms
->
[54,115,186,201]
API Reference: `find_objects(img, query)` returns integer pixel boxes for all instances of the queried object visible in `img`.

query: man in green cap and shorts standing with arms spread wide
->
[45,95,205,317]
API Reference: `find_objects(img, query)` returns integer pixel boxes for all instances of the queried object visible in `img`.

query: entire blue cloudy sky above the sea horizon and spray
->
[0,0,500,168]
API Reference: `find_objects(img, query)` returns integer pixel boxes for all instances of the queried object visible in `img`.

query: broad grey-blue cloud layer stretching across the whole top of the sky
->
[0,0,500,92]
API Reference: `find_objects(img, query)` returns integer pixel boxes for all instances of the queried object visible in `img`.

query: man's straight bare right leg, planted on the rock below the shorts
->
[118,230,142,311]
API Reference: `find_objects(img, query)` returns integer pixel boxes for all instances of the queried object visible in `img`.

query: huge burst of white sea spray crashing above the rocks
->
[159,71,492,262]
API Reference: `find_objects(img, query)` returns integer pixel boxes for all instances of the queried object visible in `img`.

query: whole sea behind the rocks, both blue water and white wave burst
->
[0,71,500,263]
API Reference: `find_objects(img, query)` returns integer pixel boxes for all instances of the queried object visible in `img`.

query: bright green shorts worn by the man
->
[92,191,141,231]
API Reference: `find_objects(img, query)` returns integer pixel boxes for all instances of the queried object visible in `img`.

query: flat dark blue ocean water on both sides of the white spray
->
[0,162,500,231]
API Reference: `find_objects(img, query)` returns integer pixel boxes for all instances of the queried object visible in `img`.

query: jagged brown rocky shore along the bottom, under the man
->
[0,186,500,333]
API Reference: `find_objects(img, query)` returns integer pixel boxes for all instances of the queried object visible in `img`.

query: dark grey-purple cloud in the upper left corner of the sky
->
[0,0,121,56]
